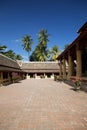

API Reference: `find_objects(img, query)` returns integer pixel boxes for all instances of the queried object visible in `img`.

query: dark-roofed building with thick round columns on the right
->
[57,22,87,81]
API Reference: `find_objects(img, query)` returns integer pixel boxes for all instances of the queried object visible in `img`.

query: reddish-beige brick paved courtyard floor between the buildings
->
[0,79,87,130]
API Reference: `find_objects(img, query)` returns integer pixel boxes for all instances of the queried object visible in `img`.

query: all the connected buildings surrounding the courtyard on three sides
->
[0,22,87,91]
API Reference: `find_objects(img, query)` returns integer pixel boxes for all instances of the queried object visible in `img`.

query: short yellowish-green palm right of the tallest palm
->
[49,45,60,61]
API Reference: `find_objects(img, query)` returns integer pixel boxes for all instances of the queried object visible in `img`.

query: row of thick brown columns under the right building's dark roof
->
[58,44,82,79]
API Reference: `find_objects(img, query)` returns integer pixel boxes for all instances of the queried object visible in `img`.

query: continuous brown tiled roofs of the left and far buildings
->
[0,54,59,73]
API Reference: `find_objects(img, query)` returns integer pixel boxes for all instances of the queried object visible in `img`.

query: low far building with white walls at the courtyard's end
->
[22,61,59,79]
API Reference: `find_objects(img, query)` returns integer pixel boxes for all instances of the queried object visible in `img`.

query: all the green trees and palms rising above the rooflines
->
[0,29,61,61]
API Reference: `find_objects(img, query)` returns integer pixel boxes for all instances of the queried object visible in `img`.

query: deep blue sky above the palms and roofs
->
[0,0,87,60]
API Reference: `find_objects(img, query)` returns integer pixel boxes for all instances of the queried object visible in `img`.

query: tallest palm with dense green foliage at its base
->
[30,29,49,61]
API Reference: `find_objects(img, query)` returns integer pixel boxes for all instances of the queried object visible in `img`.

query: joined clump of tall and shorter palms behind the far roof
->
[30,29,60,61]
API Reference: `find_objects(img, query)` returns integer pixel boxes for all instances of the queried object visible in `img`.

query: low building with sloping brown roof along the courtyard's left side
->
[0,54,23,85]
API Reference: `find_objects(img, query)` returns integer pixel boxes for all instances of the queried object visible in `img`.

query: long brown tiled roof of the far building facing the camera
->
[22,62,59,72]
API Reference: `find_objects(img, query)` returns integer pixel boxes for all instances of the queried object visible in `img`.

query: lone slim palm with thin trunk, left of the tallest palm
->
[22,35,33,58]
